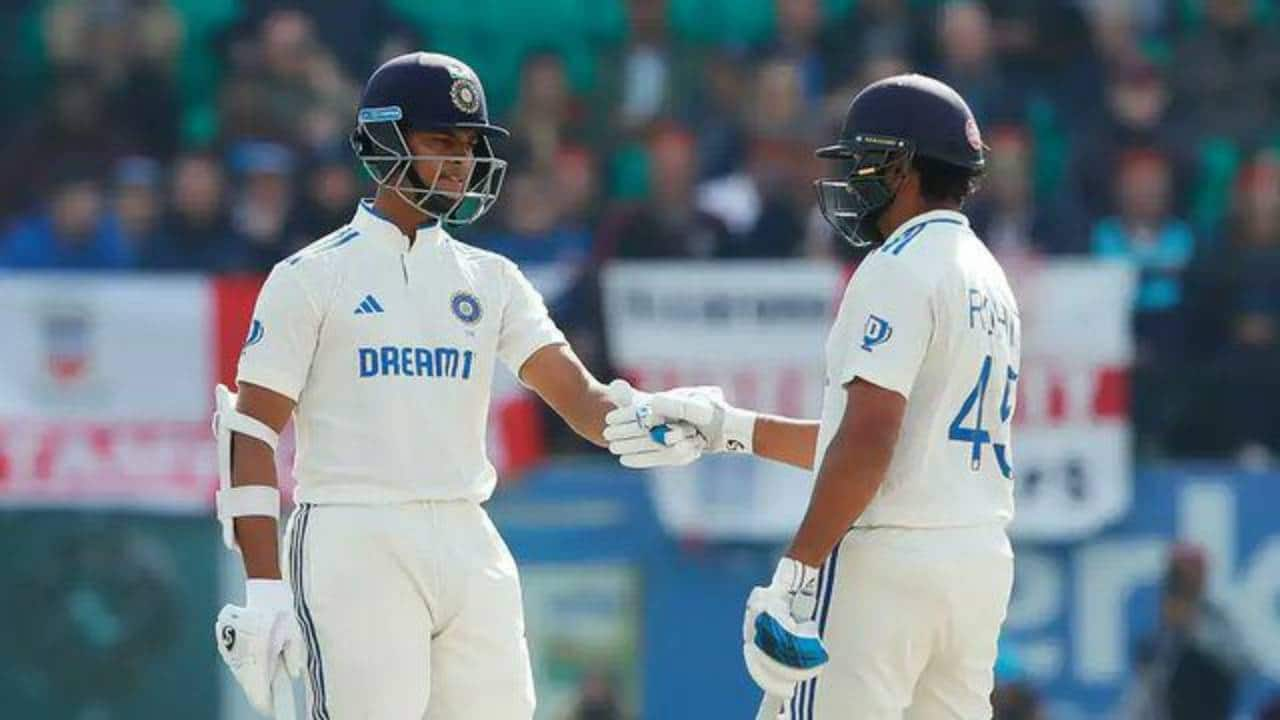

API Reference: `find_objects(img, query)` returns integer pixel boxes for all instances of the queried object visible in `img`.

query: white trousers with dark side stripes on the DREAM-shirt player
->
[283,501,534,720]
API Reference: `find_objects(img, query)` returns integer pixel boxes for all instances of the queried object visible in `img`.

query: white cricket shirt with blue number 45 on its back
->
[815,210,1021,528]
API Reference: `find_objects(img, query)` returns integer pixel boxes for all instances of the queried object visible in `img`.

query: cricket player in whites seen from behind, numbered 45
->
[605,74,1021,720]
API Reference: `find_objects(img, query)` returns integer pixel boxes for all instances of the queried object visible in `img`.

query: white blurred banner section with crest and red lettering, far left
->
[0,274,216,511]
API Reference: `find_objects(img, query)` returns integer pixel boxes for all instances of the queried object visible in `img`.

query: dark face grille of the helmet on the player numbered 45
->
[813,135,915,247]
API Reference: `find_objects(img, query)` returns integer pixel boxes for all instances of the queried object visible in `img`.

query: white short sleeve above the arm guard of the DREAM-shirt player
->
[236,264,320,401]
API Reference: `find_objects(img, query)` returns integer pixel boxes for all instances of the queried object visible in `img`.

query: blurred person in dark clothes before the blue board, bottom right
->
[1119,544,1249,720]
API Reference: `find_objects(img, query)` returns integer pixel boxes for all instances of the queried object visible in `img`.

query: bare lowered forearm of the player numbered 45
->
[787,422,896,566]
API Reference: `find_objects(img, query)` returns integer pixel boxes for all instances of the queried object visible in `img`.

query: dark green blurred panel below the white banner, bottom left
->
[0,510,220,720]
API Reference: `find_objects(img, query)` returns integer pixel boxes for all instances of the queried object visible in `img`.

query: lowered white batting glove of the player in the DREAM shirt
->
[214,579,305,716]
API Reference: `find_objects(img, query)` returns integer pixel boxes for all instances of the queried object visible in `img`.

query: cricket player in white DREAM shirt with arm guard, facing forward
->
[208,53,703,720]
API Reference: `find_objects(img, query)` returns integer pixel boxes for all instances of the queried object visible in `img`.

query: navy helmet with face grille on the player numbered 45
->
[814,74,986,246]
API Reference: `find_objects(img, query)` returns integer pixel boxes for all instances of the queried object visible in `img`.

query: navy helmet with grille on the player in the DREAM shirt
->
[351,53,509,224]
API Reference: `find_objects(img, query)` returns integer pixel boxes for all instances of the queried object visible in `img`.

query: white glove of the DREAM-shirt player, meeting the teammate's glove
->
[604,379,707,469]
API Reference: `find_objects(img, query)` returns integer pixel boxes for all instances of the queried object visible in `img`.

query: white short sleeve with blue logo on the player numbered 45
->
[835,255,934,397]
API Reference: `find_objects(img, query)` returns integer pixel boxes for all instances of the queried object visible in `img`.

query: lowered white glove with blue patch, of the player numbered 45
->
[742,557,827,698]
